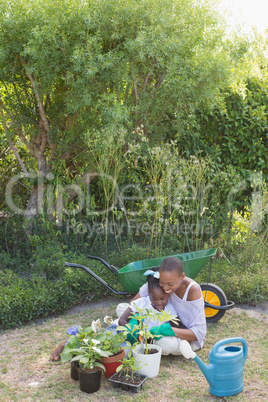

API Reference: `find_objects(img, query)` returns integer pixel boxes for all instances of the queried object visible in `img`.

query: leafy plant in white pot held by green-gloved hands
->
[117,306,178,377]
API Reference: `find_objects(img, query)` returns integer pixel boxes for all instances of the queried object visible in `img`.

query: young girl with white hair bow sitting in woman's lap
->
[118,270,177,330]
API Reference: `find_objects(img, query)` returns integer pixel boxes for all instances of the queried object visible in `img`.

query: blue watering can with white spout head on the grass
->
[180,338,248,396]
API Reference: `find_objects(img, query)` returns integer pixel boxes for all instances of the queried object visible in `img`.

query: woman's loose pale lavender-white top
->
[139,281,207,348]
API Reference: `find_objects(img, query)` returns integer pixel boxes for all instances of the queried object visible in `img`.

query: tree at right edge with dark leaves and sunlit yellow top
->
[175,28,268,178]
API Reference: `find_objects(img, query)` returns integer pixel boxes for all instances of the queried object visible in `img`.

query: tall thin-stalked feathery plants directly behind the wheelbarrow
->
[85,126,242,254]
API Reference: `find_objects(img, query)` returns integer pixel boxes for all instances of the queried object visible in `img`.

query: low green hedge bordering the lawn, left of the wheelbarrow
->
[0,268,114,329]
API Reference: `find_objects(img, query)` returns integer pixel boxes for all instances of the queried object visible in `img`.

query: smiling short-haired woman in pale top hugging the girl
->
[129,257,206,355]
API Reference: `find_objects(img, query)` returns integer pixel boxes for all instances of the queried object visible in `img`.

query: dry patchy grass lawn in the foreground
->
[0,302,268,402]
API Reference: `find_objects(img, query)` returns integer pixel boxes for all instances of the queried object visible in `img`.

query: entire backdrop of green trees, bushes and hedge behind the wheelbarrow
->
[0,0,268,327]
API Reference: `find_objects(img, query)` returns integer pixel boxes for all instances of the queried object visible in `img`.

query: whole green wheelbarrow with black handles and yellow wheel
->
[65,248,234,322]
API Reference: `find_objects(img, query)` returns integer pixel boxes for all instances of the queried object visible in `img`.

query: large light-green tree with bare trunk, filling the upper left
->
[0,0,233,228]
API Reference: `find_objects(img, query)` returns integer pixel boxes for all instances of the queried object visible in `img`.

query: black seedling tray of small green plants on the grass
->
[109,351,147,393]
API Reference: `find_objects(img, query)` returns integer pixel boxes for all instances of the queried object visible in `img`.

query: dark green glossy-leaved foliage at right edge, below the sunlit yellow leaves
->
[178,71,268,181]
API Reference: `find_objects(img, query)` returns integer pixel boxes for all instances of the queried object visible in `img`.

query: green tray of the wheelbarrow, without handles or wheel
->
[115,248,217,293]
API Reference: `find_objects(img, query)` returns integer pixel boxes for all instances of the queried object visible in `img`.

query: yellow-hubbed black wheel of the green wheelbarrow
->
[200,283,227,322]
